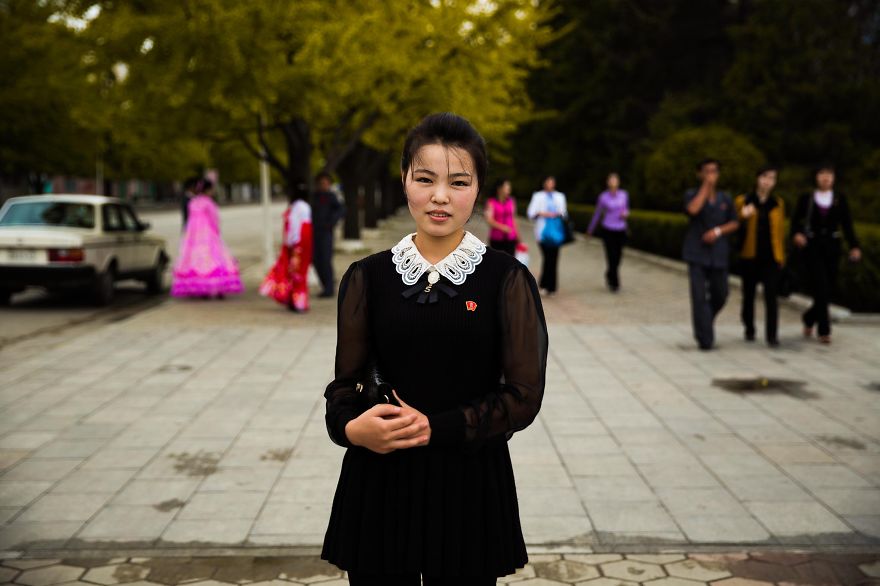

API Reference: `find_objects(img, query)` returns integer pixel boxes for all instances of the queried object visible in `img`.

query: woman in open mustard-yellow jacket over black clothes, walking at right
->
[734,166,785,347]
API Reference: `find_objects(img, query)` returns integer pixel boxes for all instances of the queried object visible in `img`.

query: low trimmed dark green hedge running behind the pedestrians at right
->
[521,204,880,312]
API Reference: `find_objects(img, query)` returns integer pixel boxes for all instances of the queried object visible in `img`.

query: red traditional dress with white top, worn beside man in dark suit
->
[260,199,312,312]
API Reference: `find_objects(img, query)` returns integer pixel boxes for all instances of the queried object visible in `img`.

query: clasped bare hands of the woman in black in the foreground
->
[345,391,431,454]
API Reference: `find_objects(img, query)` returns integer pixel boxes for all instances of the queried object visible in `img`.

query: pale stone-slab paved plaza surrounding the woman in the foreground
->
[0,205,880,586]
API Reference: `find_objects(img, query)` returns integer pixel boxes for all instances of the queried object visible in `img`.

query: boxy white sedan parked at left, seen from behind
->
[0,194,168,305]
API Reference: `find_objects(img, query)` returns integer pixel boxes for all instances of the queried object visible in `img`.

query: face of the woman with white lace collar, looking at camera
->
[403,144,478,238]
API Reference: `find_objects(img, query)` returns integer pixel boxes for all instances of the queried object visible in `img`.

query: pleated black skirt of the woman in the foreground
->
[321,438,528,576]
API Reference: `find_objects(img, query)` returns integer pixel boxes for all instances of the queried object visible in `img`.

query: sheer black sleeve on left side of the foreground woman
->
[324,263,369,447]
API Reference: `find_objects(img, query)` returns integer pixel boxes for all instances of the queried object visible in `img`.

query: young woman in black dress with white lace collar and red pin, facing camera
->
[322,113,548,586]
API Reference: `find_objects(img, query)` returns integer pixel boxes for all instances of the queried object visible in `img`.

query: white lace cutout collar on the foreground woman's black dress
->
[391,231,486,285]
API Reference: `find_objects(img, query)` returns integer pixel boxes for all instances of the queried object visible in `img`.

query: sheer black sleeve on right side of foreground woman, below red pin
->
[428,263,548,445]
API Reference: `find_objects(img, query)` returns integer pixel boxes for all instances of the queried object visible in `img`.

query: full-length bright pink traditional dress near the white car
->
[171,195,244,297]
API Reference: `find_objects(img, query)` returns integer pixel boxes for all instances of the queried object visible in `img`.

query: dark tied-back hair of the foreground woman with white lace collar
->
[400,112,489,193]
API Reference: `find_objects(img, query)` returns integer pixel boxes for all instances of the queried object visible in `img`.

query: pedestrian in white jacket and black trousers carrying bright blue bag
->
[526,175,568,295]
